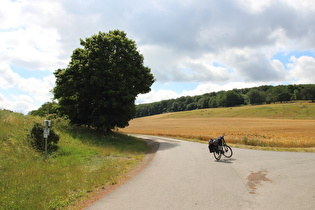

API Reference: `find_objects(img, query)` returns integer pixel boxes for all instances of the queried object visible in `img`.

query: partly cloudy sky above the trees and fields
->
[0,0,315,114]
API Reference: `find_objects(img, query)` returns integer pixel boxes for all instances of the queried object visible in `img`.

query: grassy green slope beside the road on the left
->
[0,111,149,209]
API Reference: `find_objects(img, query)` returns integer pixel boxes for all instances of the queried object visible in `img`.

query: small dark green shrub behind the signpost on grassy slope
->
[29,123,59,153]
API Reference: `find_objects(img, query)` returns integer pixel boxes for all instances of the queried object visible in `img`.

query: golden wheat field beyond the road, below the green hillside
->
[120,102,315,147]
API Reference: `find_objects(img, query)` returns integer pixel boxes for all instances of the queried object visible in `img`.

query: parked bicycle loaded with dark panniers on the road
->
[208,135,233,160]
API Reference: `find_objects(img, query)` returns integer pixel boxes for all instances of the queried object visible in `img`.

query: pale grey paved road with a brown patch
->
[87,135,315,210]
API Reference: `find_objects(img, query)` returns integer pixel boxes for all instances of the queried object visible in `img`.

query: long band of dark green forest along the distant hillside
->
[135,84,315,118]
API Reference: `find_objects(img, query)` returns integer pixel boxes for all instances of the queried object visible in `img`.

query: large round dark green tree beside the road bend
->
[53,30,155,131]
